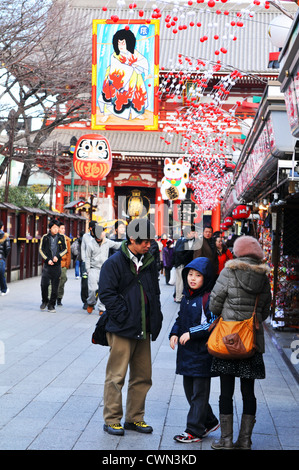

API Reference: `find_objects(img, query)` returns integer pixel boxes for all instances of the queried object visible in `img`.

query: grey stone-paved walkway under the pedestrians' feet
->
[0,270,299,452]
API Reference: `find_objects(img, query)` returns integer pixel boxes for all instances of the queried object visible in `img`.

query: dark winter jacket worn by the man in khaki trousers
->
[99,242,163,341]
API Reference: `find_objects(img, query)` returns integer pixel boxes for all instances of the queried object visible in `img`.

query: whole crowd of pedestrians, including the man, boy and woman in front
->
[0,218,271,449]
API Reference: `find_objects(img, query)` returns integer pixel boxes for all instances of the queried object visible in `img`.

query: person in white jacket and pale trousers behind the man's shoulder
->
[85,225,122,315]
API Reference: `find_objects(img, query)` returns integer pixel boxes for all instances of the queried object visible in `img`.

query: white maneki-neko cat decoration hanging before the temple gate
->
[161,158,190,201]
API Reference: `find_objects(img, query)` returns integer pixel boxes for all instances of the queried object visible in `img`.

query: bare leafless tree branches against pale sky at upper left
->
[0,0,91,186]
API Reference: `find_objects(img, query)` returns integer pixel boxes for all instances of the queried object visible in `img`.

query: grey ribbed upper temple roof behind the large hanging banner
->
[71,0,298,73]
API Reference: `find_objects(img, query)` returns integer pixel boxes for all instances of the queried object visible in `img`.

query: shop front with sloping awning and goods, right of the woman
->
[222,82,299,326]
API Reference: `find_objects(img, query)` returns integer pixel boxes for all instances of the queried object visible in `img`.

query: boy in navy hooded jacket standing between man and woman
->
[169,257,219,443]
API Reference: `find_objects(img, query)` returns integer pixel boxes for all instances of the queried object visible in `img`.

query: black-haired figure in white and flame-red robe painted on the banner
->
[98,29,151,122]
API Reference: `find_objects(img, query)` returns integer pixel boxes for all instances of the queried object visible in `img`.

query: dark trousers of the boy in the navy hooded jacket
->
[183,376,218,437]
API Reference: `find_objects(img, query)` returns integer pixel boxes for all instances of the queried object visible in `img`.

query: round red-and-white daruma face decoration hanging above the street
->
[73,134,112,181]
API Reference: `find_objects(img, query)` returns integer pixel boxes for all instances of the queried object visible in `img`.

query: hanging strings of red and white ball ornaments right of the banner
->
[103,0,276,210]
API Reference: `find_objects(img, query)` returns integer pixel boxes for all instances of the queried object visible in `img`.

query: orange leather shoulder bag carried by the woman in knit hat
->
[207,295,259,359]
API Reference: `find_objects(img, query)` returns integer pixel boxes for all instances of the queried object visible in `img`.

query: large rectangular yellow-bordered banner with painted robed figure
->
[91,20,159,131]
